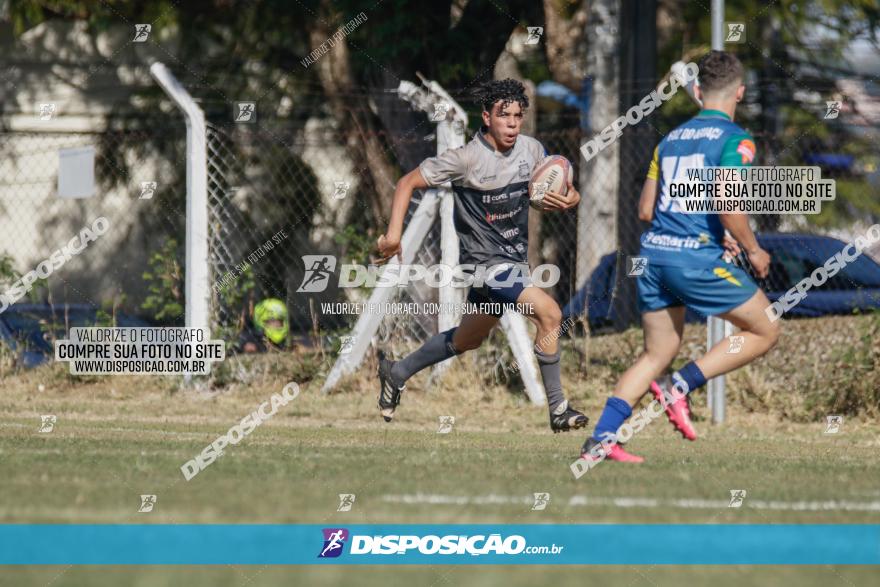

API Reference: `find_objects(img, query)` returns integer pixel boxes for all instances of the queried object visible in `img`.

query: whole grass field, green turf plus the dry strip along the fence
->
[0,320,880,586]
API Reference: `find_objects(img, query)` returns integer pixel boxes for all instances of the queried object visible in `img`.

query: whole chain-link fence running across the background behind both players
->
[6,77,880,368]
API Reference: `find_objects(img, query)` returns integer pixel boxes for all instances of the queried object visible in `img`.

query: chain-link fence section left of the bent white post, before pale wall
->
[0,119,186,322]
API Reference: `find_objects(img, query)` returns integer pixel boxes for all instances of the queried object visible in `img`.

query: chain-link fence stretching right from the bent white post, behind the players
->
[203,105,871,344]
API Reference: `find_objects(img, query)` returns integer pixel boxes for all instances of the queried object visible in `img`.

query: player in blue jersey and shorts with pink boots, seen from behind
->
[581,51,779,463]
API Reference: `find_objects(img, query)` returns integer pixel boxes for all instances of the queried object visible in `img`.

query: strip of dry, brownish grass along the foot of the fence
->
[0,315,880,431]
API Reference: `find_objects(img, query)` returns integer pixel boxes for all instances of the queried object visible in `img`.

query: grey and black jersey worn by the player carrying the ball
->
[419,129,546,267]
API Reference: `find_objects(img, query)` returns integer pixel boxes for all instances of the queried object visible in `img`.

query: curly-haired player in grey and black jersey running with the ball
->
[378,79,587,432]
